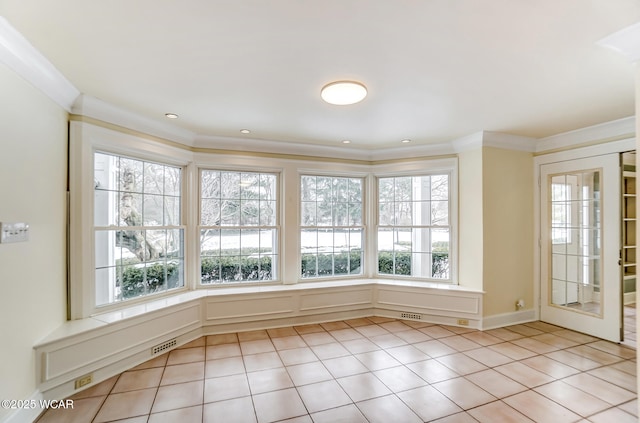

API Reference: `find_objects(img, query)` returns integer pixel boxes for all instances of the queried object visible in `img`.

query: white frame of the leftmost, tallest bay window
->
[67,124,192,320]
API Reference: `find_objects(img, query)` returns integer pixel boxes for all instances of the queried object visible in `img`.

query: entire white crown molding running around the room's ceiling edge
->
[0,16,640,161]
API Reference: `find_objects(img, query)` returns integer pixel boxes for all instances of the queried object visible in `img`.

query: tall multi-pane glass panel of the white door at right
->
[548,170,603,315]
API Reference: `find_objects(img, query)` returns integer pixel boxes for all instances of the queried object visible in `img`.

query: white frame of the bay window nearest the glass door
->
[371,158,459,285]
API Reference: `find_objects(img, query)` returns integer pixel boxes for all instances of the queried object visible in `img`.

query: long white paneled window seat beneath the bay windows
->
[34,279,482,406]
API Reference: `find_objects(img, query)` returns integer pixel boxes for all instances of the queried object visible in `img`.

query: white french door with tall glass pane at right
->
[540,154,622,342]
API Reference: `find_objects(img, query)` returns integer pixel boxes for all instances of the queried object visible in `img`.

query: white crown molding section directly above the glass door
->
[535,116,636,153]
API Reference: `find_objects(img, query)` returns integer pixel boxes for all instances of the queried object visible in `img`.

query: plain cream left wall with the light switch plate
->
[0,64,67,421]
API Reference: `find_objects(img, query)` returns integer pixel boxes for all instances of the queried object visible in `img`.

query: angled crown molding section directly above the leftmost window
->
[71,94,196,147]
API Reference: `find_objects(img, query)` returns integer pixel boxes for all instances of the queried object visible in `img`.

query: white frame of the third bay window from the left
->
[296,169,370,283]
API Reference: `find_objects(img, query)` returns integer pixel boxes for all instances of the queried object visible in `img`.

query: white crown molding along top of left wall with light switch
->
[0,16,80,111]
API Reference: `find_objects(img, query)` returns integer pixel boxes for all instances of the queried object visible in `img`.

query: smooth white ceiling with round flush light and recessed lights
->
[0,0,640,150]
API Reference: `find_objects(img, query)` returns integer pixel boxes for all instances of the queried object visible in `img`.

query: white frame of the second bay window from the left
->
[194,164,284,289]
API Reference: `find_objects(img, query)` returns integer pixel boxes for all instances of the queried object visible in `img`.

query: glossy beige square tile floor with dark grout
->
[38,317,638,423]
